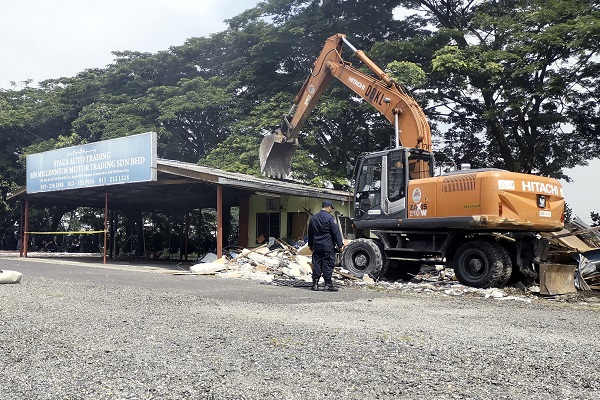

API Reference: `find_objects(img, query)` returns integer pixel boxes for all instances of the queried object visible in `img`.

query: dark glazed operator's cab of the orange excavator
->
[354,148,433,225]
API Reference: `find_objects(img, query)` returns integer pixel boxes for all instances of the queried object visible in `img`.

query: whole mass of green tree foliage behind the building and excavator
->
[0,0,600,231]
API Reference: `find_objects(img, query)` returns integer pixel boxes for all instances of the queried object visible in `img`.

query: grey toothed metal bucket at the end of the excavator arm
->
[259,134,297,178]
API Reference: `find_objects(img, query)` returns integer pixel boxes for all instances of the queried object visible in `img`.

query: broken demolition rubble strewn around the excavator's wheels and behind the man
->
[178,221,600,301]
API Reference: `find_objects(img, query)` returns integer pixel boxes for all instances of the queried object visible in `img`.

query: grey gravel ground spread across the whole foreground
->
[0,270,600,400]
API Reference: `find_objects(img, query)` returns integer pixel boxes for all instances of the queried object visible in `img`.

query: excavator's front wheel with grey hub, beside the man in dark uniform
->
[342,238,383,279]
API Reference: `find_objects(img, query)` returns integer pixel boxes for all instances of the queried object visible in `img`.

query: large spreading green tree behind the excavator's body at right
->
[386,0,600,180]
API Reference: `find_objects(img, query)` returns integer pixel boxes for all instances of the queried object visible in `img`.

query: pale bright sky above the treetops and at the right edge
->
[0,0,600,223]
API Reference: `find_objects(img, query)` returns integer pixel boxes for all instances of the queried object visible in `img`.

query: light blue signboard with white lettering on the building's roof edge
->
[27,132,157,193]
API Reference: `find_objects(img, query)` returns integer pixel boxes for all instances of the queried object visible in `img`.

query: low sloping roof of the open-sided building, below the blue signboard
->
[7,159,350,212]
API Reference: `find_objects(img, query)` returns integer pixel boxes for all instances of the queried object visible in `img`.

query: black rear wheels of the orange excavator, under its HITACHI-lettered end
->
[452,240,512,288]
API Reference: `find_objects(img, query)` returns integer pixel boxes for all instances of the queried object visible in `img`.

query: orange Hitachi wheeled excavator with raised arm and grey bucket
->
[259,34,564,288]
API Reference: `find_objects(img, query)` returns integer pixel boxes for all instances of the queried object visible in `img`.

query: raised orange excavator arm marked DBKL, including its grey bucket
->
[259,33,431,176]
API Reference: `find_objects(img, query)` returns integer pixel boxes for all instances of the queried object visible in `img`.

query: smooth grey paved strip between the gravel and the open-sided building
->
[0,254,393,304]
